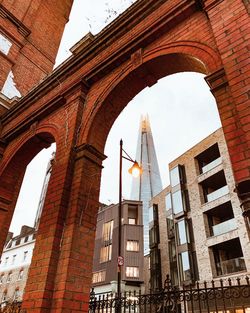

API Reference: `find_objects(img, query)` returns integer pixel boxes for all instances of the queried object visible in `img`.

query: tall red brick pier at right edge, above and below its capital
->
[203,0,250,186]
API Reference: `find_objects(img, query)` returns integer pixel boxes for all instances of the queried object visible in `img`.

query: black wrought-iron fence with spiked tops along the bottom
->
[89,277,250,313]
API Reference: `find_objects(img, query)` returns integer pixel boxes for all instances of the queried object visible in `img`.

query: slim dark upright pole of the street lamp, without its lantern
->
[117,139,123,297]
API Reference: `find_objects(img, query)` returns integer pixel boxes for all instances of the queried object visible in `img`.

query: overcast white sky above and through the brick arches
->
[11,0,221,232]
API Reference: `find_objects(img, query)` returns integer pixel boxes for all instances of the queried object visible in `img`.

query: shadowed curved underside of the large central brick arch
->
[85,44,221,152]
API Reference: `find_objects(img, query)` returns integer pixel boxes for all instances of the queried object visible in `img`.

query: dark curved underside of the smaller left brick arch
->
[0,131,56,250]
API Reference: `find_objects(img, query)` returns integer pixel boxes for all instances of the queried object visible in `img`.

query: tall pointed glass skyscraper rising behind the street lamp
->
[131,115,162,255]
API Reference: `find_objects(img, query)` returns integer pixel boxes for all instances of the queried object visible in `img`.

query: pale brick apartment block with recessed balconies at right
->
[150,129,250,289]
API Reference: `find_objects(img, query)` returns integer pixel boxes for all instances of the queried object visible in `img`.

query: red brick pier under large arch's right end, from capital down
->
[206,69,250,235]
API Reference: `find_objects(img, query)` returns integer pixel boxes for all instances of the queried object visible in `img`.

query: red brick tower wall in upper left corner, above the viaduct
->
[0,0,73,95]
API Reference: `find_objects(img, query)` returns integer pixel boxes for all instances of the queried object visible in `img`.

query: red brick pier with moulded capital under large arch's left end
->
[52,144,105,313]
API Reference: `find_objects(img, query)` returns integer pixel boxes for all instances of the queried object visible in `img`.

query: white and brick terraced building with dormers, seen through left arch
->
[0,226,36,306]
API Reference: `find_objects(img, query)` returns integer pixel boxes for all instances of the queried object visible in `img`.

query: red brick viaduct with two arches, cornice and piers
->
[0,0,250,313]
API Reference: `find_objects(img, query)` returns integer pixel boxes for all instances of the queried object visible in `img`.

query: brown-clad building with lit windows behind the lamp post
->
[93,200,144,294]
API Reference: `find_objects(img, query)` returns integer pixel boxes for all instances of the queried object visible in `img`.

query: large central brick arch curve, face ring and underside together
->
[81,41,221,152]
